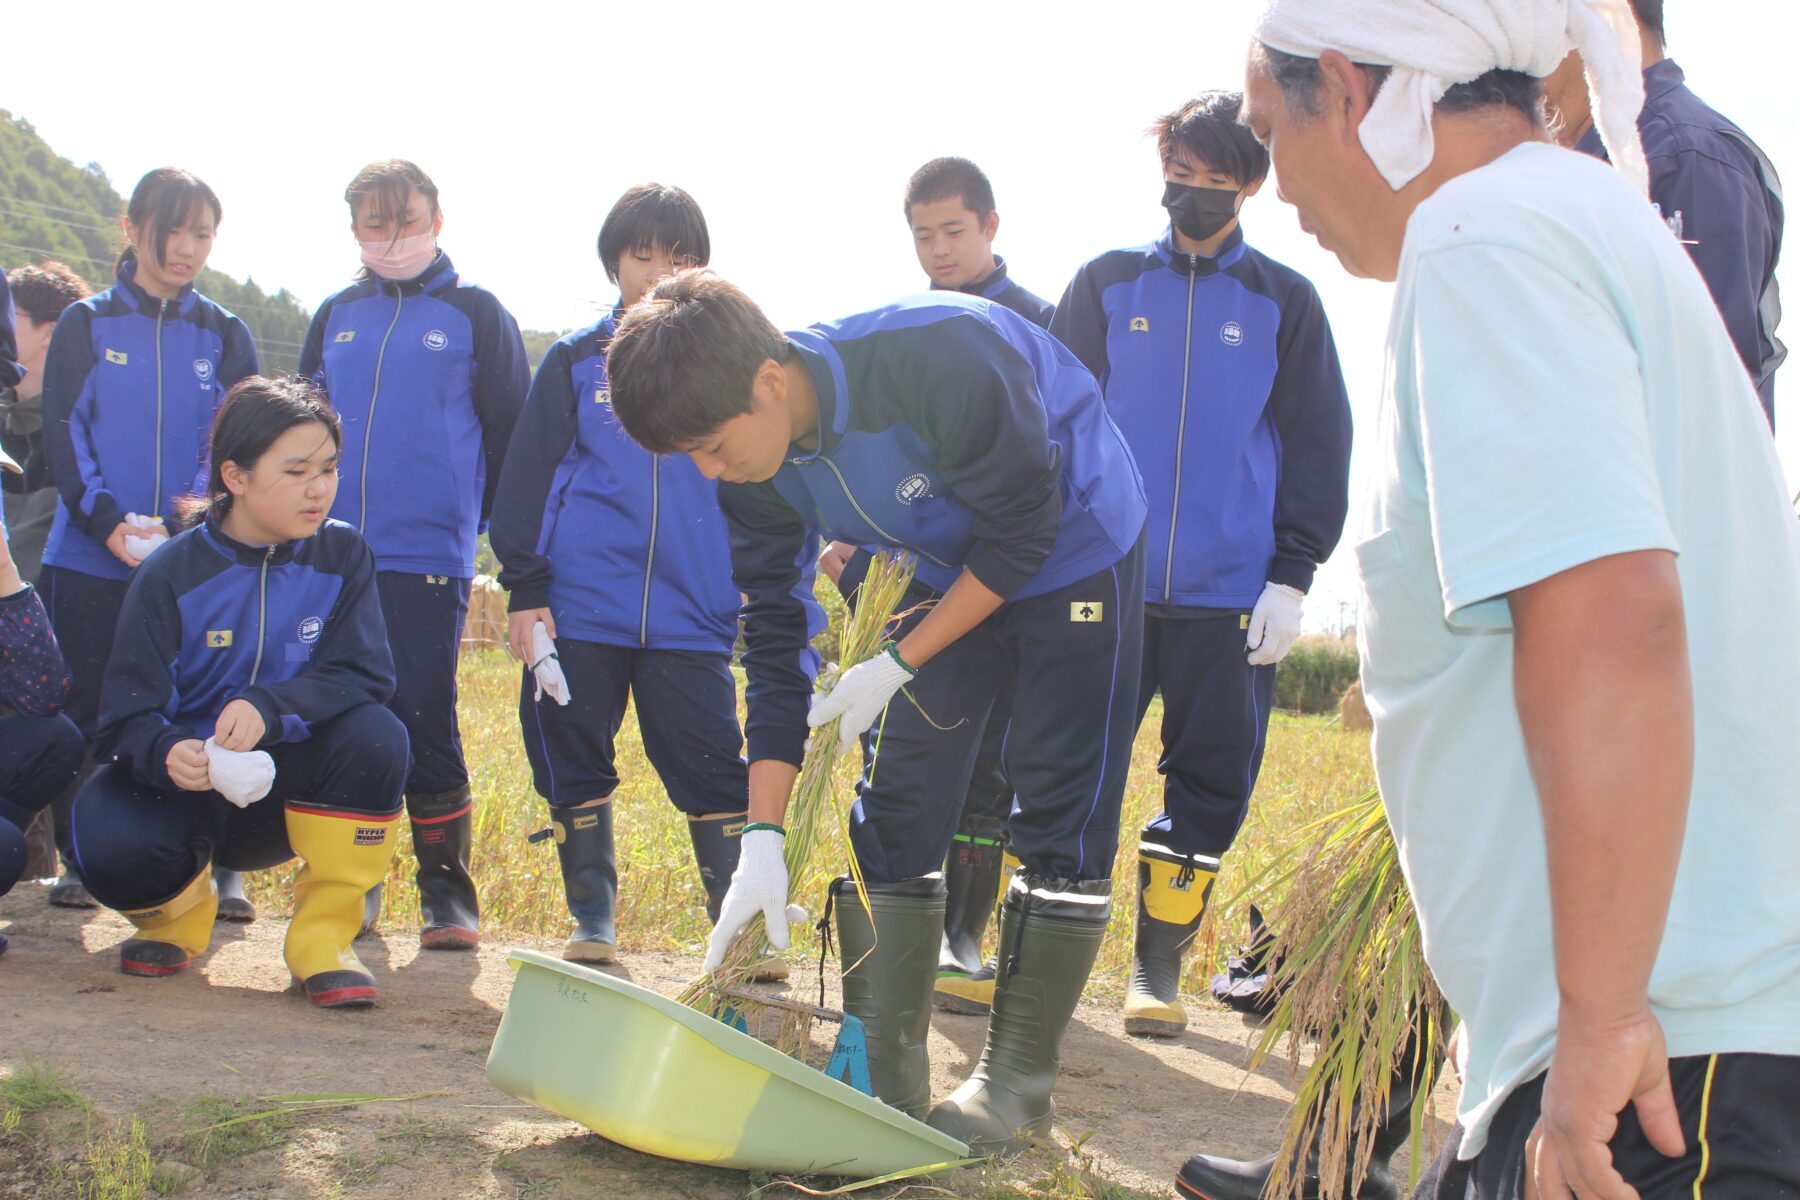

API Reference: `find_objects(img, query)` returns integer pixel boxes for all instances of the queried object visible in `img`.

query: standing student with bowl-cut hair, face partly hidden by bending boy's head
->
[491,184,766,963]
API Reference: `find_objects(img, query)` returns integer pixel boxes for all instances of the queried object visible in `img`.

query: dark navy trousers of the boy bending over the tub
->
[850,543,1143,883]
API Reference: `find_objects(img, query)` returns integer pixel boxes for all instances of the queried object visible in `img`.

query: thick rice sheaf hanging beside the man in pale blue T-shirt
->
[1246,793,1445,1200]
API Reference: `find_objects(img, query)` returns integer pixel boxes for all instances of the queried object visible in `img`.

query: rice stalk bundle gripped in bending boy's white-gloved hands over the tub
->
[677,554,913,1058]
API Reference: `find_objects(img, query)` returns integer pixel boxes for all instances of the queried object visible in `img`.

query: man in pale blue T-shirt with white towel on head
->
[1179,0,1800,1200]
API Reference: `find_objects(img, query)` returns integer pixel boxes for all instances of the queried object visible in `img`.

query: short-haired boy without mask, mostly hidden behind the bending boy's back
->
[819,158,1057,1015]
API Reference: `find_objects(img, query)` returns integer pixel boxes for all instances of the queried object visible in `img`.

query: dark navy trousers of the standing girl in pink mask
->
[374,570,468,795]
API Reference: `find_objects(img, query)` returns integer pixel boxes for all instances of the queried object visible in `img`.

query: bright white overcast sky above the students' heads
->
[0,0,1800,626]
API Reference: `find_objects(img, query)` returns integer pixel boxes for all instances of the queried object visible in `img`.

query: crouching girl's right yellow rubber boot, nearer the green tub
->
[286,808,400,1007]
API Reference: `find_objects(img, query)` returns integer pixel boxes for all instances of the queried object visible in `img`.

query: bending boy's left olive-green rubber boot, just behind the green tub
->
[832,874,943,1117]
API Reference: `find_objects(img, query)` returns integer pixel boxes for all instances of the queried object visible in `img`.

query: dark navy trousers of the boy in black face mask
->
[1132,610,1274,858]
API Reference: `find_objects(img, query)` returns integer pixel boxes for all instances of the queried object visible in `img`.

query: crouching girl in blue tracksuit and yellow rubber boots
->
[72,376,407,1007]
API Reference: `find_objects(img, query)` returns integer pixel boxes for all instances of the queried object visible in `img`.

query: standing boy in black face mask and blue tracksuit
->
[1049,92,1350,1036]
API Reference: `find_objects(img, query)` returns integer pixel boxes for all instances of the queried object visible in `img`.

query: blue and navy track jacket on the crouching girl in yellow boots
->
[97,518,394,788]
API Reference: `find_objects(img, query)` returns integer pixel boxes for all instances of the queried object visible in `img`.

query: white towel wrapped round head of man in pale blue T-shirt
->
[1256,0,1651,196]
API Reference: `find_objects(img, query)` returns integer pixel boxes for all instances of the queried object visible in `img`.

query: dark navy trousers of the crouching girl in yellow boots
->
[72,703,407,909]
